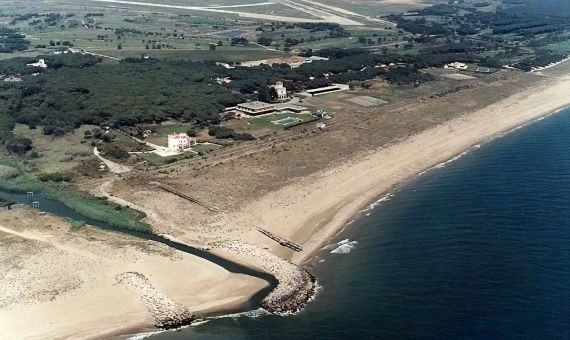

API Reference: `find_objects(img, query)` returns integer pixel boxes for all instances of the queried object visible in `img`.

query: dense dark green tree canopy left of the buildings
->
[0,55,243,135]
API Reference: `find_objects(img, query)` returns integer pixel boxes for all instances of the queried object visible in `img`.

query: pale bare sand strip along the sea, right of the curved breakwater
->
[246,73,570,265]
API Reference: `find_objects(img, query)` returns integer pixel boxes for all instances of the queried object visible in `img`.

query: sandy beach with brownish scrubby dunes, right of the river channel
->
[96,63,570,330]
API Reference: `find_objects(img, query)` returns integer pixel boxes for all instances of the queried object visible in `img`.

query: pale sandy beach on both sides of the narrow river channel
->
[0,64,570,339]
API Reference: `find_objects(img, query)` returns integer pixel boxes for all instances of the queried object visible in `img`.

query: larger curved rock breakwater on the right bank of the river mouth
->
[210,241,316,314]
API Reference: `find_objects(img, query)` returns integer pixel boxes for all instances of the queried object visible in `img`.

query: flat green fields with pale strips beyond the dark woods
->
[0,0,466,63]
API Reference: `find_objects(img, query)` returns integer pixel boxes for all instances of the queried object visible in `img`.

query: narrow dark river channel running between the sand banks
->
[0,190,279,315]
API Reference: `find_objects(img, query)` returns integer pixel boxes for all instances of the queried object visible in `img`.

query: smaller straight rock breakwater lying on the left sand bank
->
[116,272,196,329]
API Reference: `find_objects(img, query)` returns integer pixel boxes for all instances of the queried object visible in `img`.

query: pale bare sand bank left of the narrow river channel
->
[0,209,266,339]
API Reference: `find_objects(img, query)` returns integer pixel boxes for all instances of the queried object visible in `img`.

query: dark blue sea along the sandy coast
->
[152,110,570,340]
